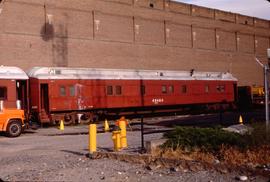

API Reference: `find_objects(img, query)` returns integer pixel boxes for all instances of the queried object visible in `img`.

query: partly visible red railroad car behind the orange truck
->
[0,66,28,111]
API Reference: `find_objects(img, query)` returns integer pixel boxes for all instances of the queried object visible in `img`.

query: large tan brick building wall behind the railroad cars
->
[0,0,270,85]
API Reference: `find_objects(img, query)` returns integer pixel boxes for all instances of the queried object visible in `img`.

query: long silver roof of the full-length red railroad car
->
[28,67,237,81]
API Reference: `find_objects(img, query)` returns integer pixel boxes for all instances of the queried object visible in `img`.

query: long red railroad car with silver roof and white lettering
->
[28,67,237,123]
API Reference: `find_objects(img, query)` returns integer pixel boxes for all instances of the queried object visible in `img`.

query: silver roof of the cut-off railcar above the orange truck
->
[0,66,28,80]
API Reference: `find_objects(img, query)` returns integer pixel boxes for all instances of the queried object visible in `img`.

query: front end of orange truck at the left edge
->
[0,108,25,137]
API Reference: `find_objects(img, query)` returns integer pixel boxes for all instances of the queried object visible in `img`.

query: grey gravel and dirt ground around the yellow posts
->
[0,126,268,182]
